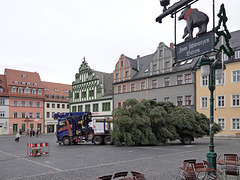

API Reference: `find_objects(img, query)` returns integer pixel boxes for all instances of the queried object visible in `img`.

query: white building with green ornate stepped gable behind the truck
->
[69,58,113,119]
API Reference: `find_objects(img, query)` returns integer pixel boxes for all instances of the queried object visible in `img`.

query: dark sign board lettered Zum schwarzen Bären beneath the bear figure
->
[176,32,214,61]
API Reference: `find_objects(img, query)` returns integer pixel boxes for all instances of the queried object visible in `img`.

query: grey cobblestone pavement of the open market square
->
[0,134,240,180]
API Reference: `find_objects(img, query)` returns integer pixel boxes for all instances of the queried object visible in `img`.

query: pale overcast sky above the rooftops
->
[0,0,240,84]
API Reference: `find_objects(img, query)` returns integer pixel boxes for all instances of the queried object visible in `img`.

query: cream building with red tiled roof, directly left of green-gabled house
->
[42,81,72,133]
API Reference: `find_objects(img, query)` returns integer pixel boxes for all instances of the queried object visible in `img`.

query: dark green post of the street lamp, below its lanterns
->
[207,67,217,169]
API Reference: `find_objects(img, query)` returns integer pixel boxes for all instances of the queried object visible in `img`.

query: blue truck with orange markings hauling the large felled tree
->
[54,112,112,146]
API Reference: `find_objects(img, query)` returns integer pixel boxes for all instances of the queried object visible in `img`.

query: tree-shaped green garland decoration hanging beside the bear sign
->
[215,4,234,57]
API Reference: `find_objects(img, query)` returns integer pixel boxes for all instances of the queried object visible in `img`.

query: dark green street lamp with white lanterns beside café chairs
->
[198,55,226,169]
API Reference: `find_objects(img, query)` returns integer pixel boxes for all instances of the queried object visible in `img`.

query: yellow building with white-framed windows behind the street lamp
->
[196,31,240,136]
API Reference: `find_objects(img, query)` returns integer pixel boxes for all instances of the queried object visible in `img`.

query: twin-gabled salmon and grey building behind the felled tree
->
[114,43,197,110]
